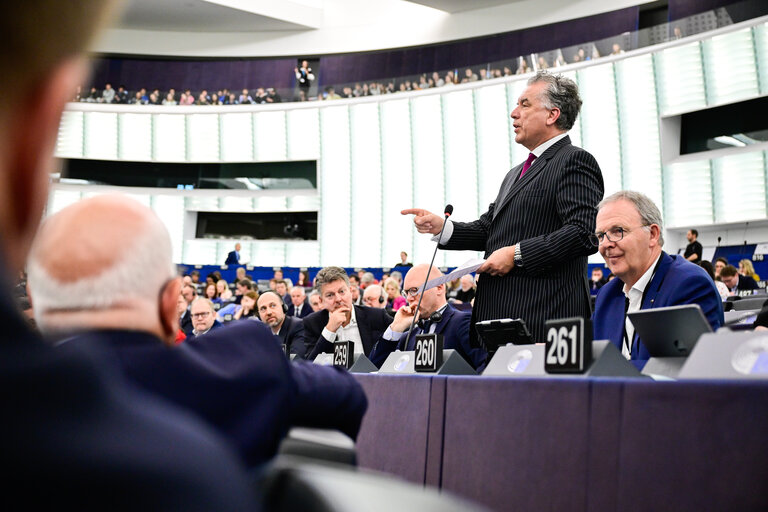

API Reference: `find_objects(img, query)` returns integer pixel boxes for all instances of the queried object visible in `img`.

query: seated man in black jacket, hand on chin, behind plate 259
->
[304,267,392,361]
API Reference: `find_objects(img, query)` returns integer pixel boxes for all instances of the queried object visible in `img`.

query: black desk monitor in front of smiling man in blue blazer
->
[628,304,712,357]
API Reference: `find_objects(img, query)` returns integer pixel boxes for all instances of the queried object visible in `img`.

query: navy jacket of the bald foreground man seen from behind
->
[64,321,367,466]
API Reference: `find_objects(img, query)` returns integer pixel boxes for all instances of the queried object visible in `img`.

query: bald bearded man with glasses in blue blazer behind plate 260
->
[370,265,486,370]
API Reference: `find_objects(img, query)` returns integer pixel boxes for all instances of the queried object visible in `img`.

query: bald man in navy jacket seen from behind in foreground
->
[29,196,366,470]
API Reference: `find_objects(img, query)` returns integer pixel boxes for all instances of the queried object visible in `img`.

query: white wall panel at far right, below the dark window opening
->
[712,151,766,222]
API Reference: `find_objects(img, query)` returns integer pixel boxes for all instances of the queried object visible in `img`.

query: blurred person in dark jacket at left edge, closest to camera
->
[0,0,256,510]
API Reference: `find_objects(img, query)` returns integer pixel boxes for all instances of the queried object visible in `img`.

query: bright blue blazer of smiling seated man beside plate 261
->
[592,251,723,368]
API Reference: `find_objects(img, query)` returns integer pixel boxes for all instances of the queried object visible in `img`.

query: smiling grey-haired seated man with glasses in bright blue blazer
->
[592,191,723,369]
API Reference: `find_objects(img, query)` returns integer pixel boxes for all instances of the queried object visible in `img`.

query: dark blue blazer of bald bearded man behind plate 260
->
[371,304,486,370]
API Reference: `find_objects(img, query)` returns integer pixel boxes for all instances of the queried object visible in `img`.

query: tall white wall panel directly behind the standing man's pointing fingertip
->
[380,99,420,266]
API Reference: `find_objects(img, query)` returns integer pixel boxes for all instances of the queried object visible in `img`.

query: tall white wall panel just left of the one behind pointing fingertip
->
[349,103,384,266]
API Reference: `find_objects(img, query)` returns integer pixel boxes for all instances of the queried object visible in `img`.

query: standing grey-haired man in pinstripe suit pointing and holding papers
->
[402,71,603,341]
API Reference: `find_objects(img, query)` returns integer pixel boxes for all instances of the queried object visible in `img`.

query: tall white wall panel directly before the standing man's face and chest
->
[474,85,514,210]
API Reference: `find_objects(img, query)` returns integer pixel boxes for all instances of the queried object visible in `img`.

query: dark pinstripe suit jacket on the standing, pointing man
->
[443,136,603,341]
